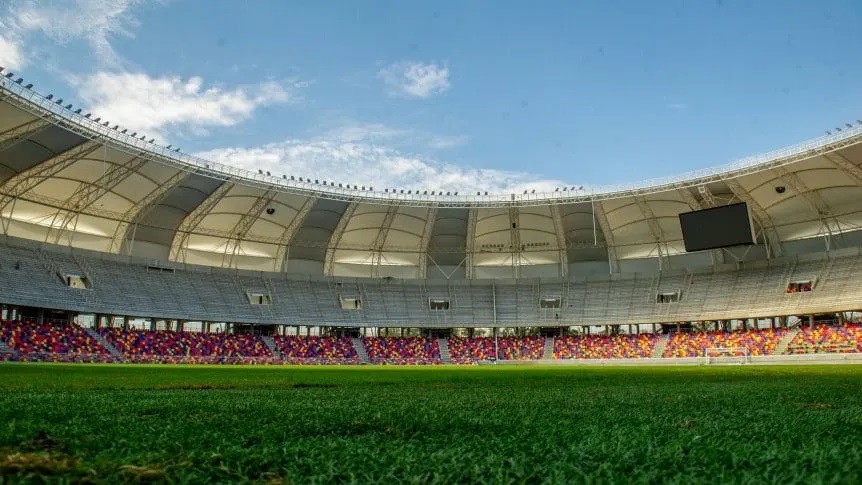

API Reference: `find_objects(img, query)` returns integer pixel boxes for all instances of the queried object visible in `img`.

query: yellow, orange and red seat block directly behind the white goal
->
[663,329,787,357]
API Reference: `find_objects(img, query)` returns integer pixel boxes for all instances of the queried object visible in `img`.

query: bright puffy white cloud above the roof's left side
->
[71,72,299,139]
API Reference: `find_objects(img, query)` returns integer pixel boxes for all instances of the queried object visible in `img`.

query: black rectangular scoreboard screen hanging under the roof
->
[679,202,754,252]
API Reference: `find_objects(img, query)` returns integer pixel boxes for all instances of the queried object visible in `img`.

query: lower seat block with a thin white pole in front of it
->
[449,337,545,364]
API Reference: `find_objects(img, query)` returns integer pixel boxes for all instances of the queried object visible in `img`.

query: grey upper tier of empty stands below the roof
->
[5,238,862,326]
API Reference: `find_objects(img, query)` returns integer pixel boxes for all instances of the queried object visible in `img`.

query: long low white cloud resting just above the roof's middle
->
[197,132,565,194]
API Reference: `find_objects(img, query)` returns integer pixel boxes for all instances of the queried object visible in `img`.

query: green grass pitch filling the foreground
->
[0,364,862,484]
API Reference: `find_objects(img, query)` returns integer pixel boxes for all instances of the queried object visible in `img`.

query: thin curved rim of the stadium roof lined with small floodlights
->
[0,75,862,207]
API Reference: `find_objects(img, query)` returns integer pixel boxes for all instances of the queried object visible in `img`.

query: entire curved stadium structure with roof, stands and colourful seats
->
[0,72,862,364]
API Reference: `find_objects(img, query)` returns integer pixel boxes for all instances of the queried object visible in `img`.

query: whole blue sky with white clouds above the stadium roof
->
[0,0,862,193]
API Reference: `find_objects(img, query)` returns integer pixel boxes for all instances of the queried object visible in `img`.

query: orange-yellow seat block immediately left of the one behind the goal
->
[554,334,658,359]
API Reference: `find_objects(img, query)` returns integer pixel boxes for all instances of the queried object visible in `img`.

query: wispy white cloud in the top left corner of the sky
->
[10,0,145,66]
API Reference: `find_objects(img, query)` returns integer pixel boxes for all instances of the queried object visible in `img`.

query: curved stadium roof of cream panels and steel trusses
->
[0,77,862,277]
